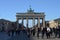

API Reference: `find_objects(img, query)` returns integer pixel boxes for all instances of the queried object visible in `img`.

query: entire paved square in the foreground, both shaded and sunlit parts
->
[0,32,60,40]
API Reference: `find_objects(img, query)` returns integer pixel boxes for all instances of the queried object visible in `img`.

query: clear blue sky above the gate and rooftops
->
[0,0,60,27]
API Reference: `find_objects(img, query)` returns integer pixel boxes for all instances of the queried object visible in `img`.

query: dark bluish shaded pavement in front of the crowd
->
[0,32,30,40]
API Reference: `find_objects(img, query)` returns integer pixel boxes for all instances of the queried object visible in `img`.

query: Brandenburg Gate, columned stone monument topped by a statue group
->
[16,8,45,28]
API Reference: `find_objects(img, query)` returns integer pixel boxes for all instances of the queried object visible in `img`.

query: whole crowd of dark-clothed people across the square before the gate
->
[0,23,60,38]
